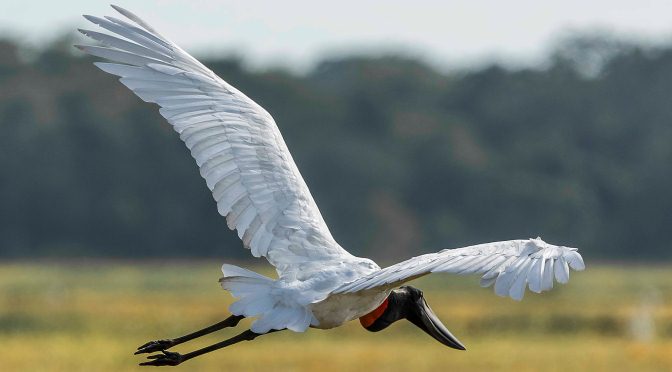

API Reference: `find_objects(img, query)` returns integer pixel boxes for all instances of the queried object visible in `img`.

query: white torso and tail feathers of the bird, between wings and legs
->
[220,256,380,333]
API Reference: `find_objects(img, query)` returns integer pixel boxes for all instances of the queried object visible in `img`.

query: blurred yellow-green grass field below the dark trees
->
[0,262,672,372]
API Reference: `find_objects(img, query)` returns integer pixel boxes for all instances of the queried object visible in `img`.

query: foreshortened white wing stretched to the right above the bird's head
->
[333,238,585,300]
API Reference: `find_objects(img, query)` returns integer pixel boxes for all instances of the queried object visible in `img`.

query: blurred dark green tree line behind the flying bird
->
[0,37,672,263]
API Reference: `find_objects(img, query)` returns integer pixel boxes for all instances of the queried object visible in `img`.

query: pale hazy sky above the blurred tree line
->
[0,0,672,71]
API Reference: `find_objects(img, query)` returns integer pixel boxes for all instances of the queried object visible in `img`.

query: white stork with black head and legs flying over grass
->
[77,5,584,366]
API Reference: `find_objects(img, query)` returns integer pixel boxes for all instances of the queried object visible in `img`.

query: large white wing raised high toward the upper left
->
[77,5,350,276]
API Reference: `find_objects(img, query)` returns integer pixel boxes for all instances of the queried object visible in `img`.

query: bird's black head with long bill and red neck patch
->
[360,286,466,350]
